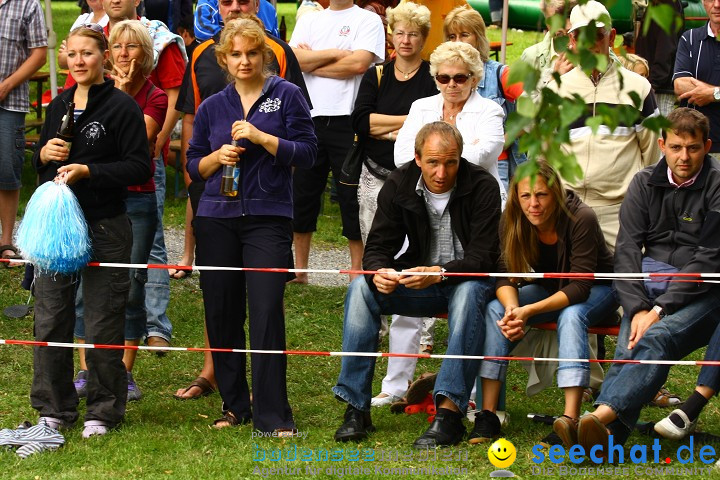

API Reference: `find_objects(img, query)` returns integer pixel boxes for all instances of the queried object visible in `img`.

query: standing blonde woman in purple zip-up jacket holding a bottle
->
[187,19,317,436]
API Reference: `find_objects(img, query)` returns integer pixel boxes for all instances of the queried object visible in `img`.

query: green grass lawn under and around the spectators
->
[5,2,720,480]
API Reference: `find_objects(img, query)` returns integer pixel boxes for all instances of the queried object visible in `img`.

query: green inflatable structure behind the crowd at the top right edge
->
[468,0,707,33]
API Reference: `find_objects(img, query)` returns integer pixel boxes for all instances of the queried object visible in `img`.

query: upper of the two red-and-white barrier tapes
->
[0,258,720,283]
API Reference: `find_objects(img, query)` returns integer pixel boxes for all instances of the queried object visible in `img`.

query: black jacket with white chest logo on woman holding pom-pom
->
[33,80,152,220]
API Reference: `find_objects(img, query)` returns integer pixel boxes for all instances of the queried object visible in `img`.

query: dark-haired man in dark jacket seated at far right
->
[578,108,720,462]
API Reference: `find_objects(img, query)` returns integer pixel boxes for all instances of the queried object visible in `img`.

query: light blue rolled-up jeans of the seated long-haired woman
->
[480,285,617,388]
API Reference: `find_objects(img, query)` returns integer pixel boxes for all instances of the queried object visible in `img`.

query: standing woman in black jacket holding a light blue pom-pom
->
[30,24,151,438]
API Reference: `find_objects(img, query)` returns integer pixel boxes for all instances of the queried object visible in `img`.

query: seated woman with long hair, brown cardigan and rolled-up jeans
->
[470,161,617,447]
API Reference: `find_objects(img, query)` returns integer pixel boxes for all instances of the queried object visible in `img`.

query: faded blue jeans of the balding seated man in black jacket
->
[333,277,494,412]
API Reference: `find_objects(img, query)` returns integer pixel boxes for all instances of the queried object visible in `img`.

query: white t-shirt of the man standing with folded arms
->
[290,5,385,117]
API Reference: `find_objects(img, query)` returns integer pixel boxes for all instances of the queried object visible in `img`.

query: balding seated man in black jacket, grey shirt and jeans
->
[333,122,500,449]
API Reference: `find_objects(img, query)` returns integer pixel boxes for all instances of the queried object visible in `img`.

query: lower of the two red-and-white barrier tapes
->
[0,339,720,367]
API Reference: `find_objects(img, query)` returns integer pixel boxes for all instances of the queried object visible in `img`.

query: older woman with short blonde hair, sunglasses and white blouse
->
[395,42,506,205]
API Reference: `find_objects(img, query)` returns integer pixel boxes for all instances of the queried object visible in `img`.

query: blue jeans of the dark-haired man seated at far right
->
[595,287,720,443]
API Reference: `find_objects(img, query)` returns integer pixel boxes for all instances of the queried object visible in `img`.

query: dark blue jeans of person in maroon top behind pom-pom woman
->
[75,192,157,340]
